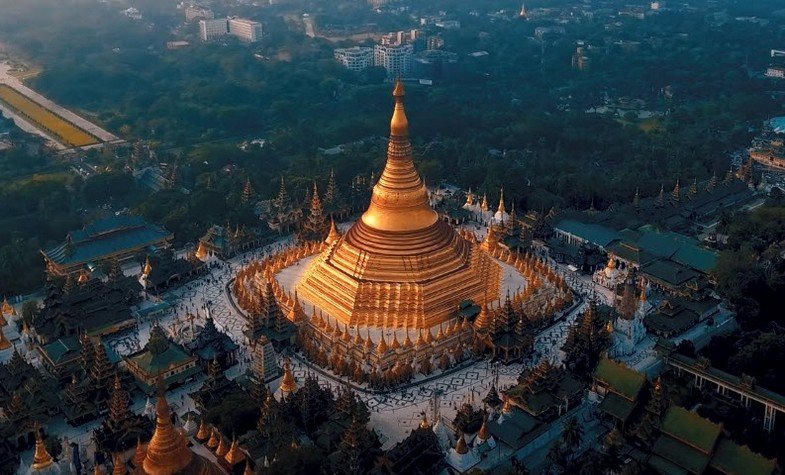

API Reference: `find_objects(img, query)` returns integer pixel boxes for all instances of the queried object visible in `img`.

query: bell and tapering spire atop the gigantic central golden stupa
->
[362,81,439,232]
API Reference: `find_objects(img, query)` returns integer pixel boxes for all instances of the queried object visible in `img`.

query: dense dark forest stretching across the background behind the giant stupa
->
[0,0,783,293]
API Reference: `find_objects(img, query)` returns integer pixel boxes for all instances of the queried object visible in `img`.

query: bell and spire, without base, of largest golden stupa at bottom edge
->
[142,378,193,475]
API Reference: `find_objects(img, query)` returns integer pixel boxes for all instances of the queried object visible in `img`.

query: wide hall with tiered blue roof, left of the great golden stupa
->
[41,216,174,276]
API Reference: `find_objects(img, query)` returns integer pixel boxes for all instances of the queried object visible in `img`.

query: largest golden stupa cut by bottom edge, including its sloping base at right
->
[134,378,223,475]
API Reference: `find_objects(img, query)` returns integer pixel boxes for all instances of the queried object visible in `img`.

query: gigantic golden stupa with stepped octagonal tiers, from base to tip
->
[297,81,501,329]
